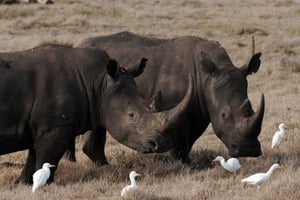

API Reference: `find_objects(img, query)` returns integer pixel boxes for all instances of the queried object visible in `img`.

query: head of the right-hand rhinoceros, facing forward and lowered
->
[202,53,264,157]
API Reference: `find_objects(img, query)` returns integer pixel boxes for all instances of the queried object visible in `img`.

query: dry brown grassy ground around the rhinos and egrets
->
[0,0,300,200]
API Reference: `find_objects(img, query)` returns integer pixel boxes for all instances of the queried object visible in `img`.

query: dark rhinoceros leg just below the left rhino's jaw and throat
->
[82,128,108,165]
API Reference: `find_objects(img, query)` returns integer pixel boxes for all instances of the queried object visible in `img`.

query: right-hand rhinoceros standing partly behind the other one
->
[74,32,265,162]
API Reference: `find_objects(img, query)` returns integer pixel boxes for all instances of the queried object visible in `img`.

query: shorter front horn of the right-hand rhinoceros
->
[248,94,265,137]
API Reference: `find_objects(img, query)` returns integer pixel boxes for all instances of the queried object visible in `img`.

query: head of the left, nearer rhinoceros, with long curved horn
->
[100,59,193,153]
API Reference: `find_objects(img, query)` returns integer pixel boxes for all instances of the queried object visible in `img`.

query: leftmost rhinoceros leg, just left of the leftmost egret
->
[15,148,36,184]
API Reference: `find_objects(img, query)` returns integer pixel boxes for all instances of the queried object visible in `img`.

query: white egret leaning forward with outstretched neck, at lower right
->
[241,163,280,189]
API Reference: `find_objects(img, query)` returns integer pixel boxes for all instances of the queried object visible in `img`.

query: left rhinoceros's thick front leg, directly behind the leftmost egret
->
[31,127,74,183]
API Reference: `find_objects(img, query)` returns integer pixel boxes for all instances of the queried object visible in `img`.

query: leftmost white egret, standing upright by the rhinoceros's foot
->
[32,163,55,192]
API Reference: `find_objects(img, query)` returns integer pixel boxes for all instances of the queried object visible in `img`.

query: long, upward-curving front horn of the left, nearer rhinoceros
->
[157,74,193,133]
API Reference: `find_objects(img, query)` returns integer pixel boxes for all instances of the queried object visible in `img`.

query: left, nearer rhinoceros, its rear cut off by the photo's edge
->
[0,45,193,183]
